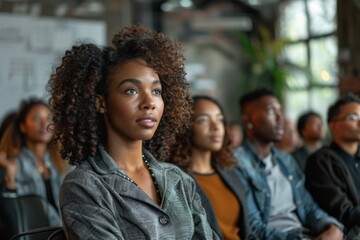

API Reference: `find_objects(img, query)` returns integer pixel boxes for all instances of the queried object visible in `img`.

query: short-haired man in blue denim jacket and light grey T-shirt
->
[235,88,343,240]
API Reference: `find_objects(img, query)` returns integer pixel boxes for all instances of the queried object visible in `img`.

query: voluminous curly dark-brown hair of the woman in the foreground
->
[47,25,191,165]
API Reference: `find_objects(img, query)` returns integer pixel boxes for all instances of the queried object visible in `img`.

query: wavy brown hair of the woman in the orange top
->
[169,95,235,172]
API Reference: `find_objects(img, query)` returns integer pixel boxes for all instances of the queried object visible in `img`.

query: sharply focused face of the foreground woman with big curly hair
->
[103,60,164,141]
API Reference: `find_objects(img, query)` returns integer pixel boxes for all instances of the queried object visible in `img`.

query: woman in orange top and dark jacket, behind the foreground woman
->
[170,96,253,240]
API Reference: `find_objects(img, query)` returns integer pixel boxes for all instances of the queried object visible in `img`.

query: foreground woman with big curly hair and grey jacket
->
[47,26,216,240]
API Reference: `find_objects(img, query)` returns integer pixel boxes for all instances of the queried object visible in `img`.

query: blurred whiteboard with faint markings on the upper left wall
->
[0,14,106,120]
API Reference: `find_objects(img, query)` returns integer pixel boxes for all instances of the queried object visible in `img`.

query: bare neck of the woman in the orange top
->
[191,149,214,174]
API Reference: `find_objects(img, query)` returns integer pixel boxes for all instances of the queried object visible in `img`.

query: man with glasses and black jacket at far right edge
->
[305,94,360,239]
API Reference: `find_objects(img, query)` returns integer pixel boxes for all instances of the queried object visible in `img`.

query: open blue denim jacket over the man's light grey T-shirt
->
[234,140,343,240]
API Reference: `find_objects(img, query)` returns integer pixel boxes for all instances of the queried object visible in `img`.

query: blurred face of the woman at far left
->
[20,104,53,143]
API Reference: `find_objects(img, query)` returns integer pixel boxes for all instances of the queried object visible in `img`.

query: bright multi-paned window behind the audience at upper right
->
[279,0,338,121]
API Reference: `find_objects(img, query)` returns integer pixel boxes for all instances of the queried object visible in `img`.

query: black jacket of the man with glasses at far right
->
[305,147,360,232]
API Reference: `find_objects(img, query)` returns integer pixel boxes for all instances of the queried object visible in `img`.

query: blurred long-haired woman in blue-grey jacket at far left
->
[0,98,64,226]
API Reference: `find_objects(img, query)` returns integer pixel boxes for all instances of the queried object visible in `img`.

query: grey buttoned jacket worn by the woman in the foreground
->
[60,146,217,240]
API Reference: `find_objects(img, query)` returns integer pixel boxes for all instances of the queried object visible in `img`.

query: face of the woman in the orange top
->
[192,99,225,152]
